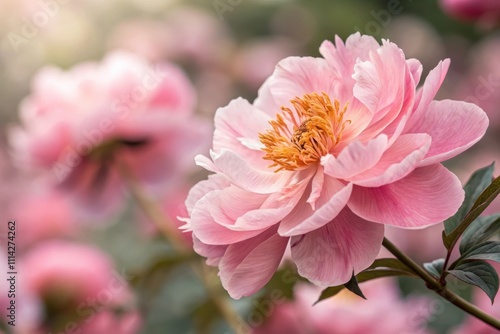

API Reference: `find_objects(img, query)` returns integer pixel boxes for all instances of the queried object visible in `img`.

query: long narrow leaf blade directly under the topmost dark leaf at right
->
[443,176,500,250]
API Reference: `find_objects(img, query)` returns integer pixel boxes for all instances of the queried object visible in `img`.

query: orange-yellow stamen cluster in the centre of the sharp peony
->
[259,93,351,172]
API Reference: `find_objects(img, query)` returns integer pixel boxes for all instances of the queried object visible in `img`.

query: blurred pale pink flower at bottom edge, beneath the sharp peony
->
[253,279,431,334]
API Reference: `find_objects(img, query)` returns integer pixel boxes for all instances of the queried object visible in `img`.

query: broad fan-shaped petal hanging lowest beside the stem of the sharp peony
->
[291,208,384,287]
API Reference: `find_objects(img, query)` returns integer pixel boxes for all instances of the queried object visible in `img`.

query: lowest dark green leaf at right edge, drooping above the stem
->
[448,261,499,303]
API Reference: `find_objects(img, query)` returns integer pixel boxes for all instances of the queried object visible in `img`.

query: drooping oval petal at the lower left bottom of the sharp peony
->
[219,227,289,299]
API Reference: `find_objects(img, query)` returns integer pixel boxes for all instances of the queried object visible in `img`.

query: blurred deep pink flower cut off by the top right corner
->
[440,0,500,21]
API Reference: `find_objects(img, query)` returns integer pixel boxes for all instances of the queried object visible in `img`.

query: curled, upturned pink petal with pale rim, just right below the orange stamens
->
[348,133,431,187]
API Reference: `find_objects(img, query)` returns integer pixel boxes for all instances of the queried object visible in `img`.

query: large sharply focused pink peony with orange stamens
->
[186,33,488,298]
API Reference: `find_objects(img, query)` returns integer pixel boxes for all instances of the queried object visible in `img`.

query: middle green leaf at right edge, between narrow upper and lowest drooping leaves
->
[460,214,500,254]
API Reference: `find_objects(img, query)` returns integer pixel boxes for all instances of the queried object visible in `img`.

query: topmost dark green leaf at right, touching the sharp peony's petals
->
[444,163,495,234]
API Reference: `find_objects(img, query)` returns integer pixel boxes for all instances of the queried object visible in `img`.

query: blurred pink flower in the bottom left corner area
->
[19,241,137,334]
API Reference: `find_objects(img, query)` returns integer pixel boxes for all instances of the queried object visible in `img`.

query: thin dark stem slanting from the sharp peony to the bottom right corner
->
[382,238,500,329]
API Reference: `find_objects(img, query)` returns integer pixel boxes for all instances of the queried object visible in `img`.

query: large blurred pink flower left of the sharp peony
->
[10,53,209,212]
